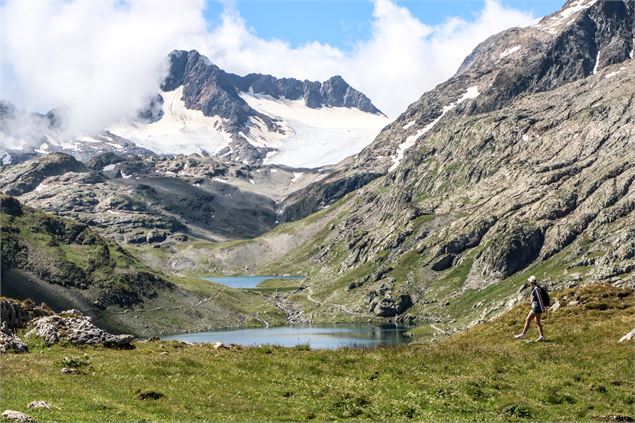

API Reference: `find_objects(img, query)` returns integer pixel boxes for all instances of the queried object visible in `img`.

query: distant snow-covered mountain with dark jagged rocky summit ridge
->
[0,50,390,168]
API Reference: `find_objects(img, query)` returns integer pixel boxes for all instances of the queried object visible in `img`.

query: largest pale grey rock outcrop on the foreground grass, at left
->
[26,310,134,348]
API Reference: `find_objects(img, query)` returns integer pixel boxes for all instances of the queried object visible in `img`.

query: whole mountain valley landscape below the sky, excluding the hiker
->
[0,0,635,421]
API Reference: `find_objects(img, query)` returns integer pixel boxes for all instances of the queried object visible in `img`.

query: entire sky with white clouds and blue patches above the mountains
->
[0,0,564,133]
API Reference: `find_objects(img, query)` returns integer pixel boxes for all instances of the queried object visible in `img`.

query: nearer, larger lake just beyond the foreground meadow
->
[161,324,410,349]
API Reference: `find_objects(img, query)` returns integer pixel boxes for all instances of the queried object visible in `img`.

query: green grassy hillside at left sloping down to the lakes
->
[0,197,286,336]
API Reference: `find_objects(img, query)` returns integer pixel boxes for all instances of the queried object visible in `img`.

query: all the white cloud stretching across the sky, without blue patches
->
[0,0,533,139]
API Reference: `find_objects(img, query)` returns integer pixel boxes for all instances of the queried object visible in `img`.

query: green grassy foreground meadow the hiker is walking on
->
[0,285,635,421]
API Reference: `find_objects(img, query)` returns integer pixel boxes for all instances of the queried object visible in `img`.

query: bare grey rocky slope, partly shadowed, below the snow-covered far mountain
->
[0,153,336,245]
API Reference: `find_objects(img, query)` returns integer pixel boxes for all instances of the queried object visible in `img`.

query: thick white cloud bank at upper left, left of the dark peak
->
[0,0,205,133]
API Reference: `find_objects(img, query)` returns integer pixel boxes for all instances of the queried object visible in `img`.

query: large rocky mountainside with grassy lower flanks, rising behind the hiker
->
[181,1,635,327]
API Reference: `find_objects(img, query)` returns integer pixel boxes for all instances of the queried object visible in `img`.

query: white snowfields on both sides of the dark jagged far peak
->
[108,87,390,168]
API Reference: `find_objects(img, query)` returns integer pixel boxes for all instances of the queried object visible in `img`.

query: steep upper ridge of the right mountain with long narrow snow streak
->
[288,0,635,224]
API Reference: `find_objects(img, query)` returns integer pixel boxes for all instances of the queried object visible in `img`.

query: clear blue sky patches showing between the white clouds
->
[205,0,564,49]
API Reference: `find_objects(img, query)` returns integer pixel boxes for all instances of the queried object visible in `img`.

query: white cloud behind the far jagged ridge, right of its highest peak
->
[190,0,534,116]
